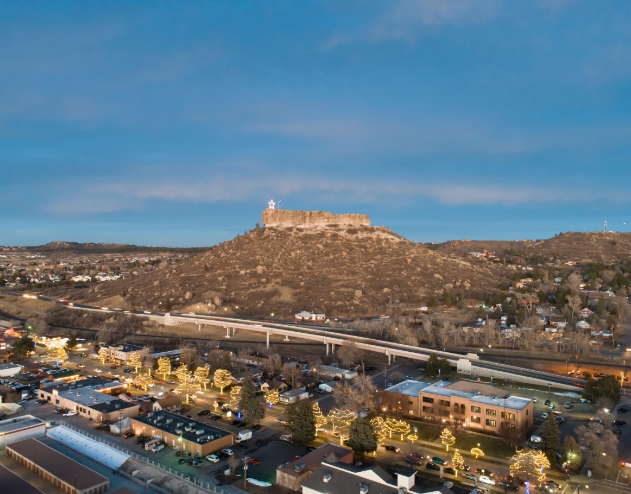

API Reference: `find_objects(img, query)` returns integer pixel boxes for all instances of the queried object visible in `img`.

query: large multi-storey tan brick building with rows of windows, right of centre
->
[380,381,534,436]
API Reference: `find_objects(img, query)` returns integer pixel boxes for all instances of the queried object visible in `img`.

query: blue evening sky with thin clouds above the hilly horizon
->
[0,0,631,246]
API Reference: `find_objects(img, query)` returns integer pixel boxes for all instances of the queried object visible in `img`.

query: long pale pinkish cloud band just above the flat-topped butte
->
[40,173,631,215]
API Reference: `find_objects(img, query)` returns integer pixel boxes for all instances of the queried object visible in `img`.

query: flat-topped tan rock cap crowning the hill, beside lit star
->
[262,209,370,227]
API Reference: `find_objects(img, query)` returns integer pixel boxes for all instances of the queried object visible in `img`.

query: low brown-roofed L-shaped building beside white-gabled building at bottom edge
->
[276,443,353,491]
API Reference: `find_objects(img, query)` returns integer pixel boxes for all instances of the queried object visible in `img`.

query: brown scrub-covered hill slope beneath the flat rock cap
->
[71,224,506,317]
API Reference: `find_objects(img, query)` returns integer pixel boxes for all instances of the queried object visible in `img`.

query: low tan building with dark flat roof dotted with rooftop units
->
[131,410,236,456]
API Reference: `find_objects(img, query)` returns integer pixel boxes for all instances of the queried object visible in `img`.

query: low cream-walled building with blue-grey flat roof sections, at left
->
[38,378,140,422]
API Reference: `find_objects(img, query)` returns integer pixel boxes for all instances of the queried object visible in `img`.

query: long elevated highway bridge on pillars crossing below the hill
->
[4,292,596,392]
